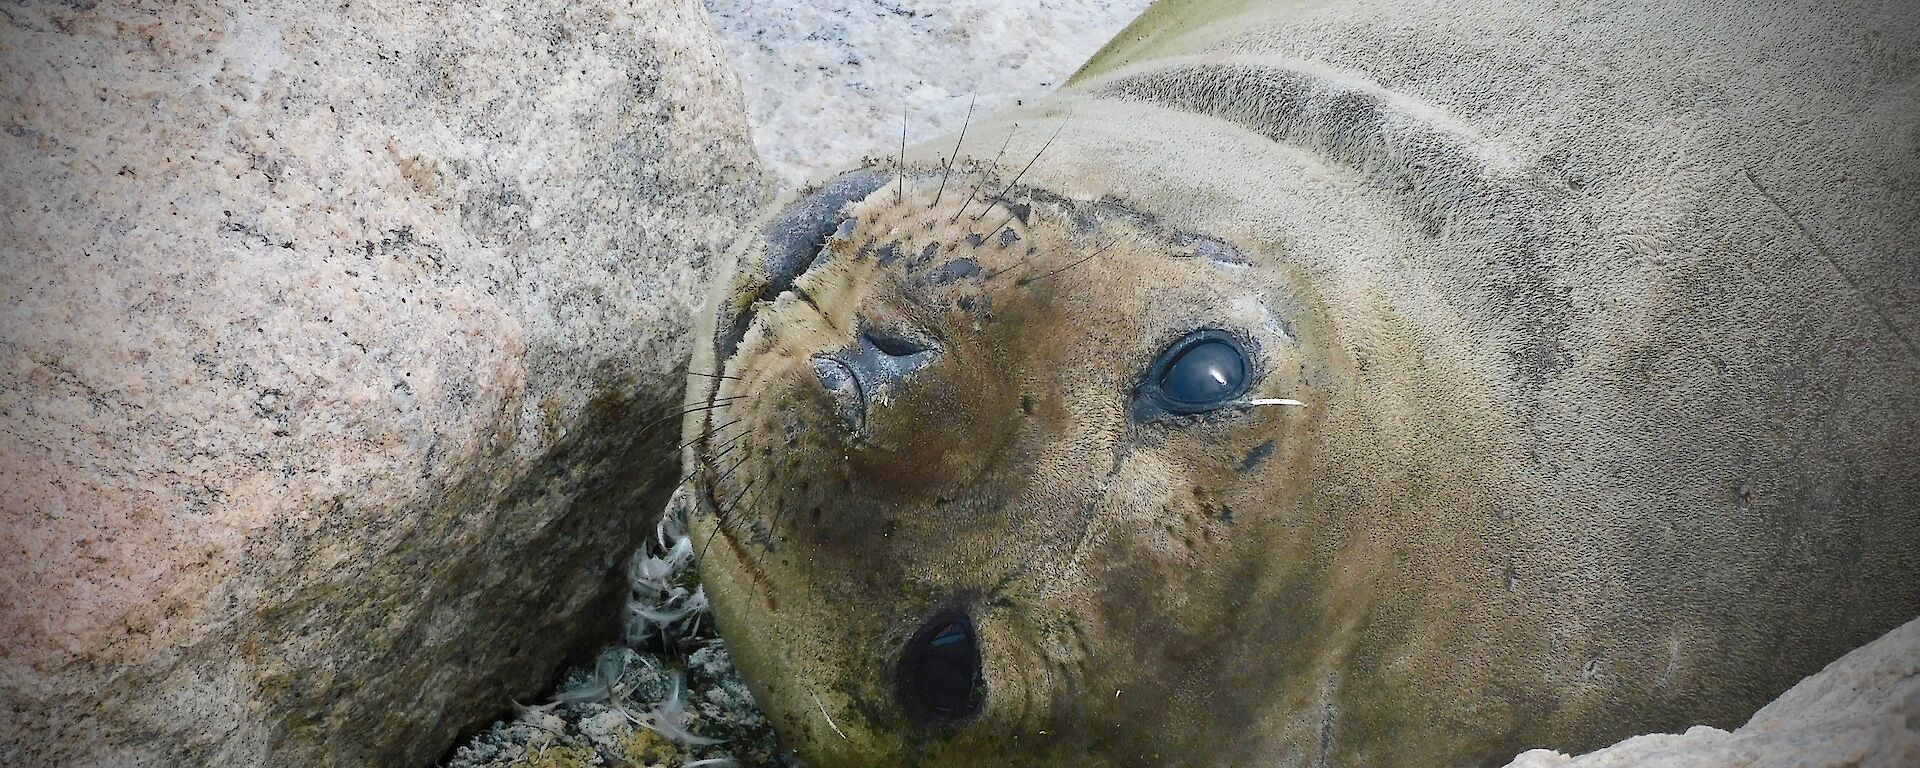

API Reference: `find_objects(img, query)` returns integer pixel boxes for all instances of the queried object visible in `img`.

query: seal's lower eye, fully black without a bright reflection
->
[900,612,985,722]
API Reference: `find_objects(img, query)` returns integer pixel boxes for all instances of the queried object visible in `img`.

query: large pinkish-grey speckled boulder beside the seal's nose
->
[0,0,764,766]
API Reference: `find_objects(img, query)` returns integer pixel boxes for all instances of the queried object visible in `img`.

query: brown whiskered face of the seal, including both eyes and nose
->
[697,171,1338,764]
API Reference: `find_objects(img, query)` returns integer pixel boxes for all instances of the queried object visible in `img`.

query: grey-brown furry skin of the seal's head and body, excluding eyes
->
[687,2,1920,766]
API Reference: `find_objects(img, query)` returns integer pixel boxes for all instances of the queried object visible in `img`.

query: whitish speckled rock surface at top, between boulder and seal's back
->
[707,0,1148,184]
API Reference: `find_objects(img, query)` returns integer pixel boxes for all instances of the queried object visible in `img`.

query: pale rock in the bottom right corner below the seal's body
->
[1507,618,1920,768]
